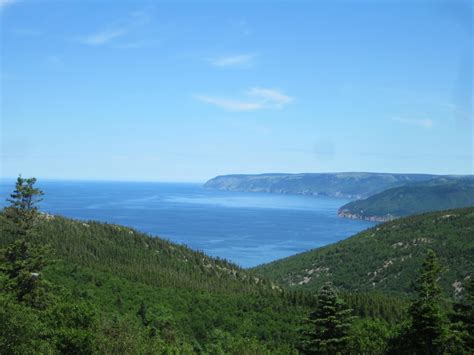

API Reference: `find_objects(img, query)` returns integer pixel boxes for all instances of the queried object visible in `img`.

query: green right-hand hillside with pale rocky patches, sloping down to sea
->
[254,208,474,295]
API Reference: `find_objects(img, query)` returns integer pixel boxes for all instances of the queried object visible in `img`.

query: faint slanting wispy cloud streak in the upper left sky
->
[79,11,150,46]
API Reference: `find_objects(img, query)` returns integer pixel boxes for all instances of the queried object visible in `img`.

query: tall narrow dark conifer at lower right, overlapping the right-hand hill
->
[407,250,449,354]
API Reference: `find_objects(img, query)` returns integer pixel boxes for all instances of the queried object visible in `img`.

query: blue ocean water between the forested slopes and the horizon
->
[0,180,374,267]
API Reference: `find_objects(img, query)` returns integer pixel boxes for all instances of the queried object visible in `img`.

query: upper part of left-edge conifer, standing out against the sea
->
[5,176,43,237]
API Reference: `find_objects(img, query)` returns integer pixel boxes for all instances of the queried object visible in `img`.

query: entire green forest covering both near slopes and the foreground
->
[0,177,474,354]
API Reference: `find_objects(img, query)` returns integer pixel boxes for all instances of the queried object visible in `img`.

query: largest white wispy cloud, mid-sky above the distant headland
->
[196,87,293,111]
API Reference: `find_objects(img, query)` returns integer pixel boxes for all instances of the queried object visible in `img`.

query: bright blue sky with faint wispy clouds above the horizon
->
[0,0,474,182]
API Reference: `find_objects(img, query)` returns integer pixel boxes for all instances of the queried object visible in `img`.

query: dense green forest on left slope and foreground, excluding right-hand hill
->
[0,178,474,354]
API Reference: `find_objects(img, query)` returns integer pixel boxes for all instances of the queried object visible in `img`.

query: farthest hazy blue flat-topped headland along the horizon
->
[204,172,434,199]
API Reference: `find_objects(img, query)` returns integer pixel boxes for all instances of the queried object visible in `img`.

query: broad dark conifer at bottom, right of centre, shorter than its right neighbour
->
[300,283,354,354]
